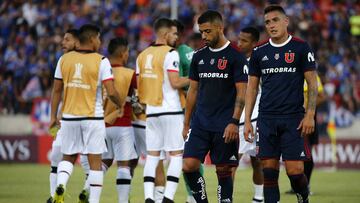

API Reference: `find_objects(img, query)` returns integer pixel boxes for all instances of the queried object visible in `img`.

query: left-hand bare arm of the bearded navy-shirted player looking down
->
[183,80,198,139]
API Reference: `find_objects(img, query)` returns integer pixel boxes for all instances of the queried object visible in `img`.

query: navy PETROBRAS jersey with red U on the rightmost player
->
[249,35,316,116]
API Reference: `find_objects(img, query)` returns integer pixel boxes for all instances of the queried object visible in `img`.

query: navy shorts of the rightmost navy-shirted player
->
[257,116,311,161]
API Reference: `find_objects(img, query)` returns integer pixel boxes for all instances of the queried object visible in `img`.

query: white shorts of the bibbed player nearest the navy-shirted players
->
[146,114,184,151]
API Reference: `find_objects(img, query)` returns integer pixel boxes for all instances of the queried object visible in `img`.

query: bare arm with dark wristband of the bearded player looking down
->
[224,82,247,143]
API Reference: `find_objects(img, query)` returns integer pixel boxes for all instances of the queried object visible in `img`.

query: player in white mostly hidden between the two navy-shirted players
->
[234,27,264,203]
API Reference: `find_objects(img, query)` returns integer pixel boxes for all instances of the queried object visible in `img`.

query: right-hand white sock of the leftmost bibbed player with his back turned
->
[88,170,104,203]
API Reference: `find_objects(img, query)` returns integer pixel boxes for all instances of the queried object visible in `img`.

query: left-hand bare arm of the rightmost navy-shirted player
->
[244,76,260,142]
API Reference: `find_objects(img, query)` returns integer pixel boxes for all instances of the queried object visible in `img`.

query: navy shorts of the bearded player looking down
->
[184,128,239,166]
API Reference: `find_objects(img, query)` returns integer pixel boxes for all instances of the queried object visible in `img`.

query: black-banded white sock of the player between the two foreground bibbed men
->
[116,167,131,203]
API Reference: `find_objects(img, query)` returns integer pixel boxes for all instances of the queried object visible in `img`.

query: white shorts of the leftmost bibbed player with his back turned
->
[58,120,107,155]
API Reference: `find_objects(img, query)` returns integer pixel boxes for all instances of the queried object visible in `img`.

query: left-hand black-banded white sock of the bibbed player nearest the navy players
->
[144,155,160,200]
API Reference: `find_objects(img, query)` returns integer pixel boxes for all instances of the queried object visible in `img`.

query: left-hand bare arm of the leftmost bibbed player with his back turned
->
[49,79,63,128]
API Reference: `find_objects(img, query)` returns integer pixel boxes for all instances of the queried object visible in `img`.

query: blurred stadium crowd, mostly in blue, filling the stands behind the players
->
[0,0,360,126]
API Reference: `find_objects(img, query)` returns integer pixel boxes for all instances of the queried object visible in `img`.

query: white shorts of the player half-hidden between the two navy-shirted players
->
[239,120,257,157]
